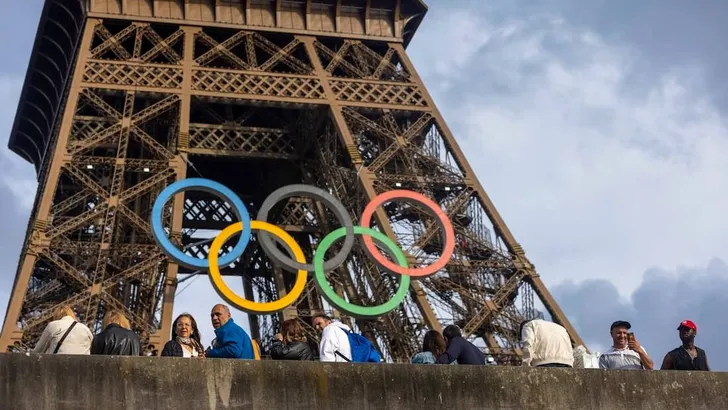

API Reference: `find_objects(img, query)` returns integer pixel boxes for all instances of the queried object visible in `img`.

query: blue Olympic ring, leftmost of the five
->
[151,178,251,271]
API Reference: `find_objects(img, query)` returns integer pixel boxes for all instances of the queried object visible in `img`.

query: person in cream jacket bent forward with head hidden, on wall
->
[521,319,574,367]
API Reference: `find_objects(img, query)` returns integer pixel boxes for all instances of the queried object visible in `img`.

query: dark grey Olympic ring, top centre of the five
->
[257,184,354,272]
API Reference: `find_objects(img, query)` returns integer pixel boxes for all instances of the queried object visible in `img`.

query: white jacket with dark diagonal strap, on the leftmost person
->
[33,316,94,354]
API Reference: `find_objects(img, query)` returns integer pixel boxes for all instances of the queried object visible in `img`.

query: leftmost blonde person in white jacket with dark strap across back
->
[33,305,94,354]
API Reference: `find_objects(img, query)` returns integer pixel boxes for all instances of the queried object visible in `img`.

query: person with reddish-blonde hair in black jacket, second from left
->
[91,310,142,356]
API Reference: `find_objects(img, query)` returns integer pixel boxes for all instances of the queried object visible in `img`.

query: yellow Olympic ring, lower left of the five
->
[208,221,308,314]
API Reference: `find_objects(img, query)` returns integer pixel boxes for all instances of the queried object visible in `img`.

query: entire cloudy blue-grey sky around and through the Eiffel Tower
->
[0,0,728,370]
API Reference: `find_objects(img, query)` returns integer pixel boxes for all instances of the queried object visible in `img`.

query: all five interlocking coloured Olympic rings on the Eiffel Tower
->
[151,178,455,318]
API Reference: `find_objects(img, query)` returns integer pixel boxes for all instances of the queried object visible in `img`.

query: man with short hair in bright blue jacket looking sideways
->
[205,304,255,360]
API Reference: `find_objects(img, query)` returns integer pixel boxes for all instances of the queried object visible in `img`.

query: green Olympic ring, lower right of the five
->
[313,225,411,318]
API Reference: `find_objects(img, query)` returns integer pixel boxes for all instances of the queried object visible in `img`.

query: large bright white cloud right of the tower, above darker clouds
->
[410,8,728,295]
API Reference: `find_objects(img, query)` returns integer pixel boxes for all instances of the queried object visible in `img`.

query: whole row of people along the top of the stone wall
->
[28,304,710,371]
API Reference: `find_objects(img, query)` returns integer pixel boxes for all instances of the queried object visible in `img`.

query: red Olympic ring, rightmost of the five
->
[360,189,455,277]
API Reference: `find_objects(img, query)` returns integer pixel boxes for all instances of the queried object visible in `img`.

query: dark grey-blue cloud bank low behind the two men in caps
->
[552,259,728,371]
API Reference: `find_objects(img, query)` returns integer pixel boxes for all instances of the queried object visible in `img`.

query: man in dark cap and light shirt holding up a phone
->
[599,320,653,370]
